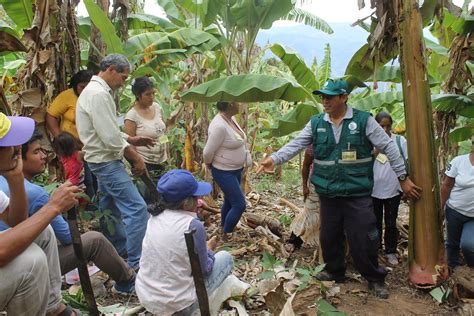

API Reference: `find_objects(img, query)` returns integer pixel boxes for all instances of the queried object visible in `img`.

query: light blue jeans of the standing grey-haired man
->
[89,160,148,268]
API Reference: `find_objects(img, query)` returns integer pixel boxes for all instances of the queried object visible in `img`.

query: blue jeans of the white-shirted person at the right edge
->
[446,205,474,268]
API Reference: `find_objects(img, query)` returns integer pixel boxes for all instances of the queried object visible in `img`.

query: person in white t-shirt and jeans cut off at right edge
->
[441,136,474,268]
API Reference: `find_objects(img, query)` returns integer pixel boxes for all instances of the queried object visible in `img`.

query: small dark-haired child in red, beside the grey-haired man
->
[53,132,84,186]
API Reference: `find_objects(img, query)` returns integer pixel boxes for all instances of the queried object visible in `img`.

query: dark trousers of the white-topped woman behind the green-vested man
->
[372,194,401,254]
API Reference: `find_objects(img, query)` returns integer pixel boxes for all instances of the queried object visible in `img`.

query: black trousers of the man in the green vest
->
[319,195,387,282]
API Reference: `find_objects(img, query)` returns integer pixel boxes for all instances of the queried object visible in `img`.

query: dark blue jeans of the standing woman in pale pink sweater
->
[211,167,247,233]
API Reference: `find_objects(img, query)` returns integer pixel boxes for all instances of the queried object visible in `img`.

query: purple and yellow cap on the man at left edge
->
[0,113,35,147]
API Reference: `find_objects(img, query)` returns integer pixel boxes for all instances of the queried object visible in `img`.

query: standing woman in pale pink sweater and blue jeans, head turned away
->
[203,102,250,233]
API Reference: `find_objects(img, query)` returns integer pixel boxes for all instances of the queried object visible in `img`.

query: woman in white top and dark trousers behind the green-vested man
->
[372,112,407,265]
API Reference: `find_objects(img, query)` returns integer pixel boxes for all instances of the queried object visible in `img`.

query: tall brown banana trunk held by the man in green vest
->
[399,0,447,286]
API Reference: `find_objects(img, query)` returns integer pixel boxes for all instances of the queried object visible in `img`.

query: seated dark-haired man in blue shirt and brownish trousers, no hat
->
[0,134,135,294]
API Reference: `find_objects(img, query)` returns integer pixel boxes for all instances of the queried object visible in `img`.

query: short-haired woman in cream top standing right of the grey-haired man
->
[125,76,167,181]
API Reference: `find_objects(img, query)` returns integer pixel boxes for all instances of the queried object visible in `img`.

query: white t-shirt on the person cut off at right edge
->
[445,154,474,217]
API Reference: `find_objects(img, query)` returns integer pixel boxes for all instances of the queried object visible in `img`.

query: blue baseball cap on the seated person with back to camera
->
[156,169,212,202]
